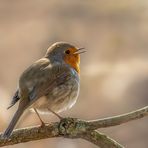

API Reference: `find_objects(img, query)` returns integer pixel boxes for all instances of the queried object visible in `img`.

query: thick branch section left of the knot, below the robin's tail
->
[0,123,60,147]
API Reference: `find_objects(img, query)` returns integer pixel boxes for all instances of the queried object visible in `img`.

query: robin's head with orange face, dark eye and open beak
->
[45,42,85,73]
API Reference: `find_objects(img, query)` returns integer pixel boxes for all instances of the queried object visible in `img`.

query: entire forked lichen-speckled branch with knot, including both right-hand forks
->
[0,106,148,148]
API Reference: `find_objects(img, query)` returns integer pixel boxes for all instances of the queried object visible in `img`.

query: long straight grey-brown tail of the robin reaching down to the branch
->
[2,109,23,139]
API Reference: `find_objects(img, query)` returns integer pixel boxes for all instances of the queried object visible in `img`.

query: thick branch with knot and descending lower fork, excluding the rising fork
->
[0,118,123,148]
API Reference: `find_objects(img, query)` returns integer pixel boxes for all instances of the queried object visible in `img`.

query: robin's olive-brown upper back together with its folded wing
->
[20,57,72,104]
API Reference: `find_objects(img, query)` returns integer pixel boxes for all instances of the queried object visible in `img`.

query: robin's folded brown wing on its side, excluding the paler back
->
[29,65,71,100]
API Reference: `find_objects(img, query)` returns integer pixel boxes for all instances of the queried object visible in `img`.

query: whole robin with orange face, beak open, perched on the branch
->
[3,42,85,138]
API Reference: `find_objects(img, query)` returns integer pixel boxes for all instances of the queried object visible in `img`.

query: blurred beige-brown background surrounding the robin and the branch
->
[0,0,148,148]
